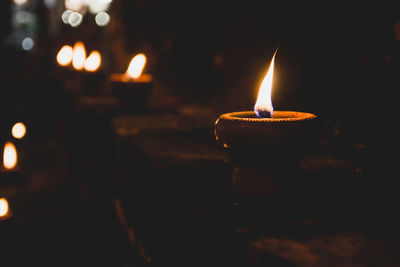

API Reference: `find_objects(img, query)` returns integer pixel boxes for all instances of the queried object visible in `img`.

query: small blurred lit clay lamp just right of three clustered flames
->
[110,53,153,110]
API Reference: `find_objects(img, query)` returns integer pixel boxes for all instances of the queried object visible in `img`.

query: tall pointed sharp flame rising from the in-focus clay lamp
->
[254,51,277,118]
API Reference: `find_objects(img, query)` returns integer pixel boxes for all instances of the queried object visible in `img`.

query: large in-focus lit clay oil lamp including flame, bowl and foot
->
[215,52,318,195]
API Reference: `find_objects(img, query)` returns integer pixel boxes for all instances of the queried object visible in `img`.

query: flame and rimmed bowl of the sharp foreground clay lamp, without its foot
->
[215,52,317,153]
